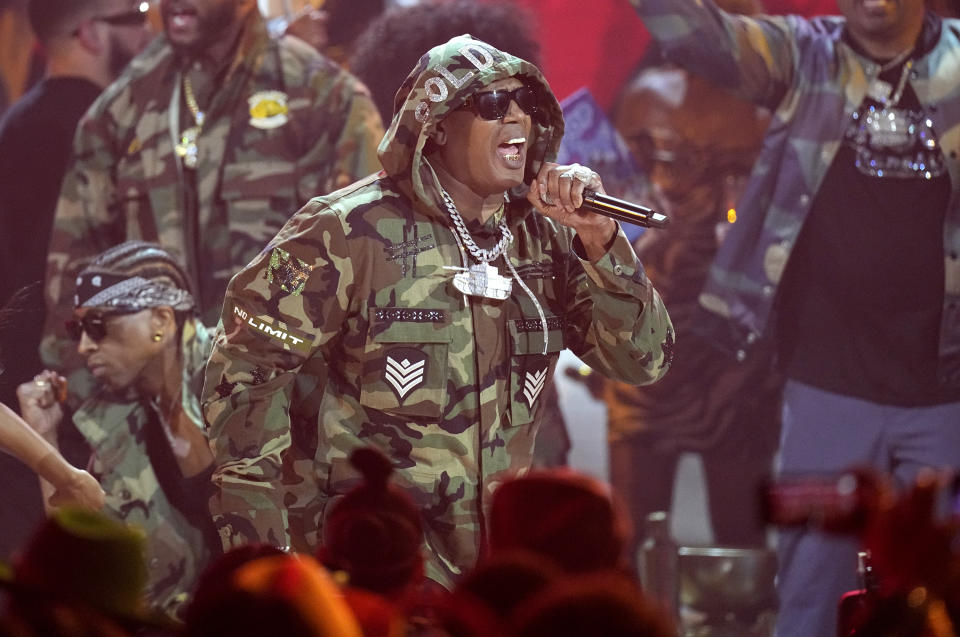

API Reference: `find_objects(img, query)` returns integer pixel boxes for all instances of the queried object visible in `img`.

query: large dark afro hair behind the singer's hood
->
[350,0,540,124]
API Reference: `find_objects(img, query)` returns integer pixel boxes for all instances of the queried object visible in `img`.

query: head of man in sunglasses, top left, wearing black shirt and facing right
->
[27,0,153,86]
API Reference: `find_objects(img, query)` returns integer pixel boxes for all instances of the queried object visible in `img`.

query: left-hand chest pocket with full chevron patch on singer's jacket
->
[360,308,451,420]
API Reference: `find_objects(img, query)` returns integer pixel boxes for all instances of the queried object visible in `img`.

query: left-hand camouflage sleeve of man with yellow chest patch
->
[40,114,122,398]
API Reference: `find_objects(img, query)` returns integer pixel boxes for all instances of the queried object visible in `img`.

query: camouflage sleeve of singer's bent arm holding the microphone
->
[567,228,674,385]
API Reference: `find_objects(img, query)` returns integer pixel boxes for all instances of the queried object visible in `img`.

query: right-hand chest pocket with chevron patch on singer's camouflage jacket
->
[510,316,566,427]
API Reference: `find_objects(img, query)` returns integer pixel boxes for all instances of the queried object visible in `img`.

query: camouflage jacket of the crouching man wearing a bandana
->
[73,319,212,617]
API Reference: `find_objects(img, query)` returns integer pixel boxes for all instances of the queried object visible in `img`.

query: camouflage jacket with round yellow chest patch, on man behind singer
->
[43,5,383,368]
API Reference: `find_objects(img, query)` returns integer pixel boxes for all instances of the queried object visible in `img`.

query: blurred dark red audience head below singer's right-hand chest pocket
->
[489,469,630,573]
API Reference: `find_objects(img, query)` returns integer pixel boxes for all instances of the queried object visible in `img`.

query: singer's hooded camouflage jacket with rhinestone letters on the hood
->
[204,36,673,585]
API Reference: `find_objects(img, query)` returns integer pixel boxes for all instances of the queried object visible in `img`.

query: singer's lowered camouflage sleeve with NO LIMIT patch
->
[203,202,349,549]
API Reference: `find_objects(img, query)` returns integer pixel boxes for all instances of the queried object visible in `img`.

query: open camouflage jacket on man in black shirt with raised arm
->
[631,0,960,386]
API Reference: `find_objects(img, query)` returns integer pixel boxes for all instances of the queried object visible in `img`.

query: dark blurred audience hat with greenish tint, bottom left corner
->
[0,508,168,637]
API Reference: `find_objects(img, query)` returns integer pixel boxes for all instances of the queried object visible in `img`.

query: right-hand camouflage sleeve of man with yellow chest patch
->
[298,69,384,201]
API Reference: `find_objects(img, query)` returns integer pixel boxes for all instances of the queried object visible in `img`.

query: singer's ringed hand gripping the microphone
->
[527,162,617,261]
